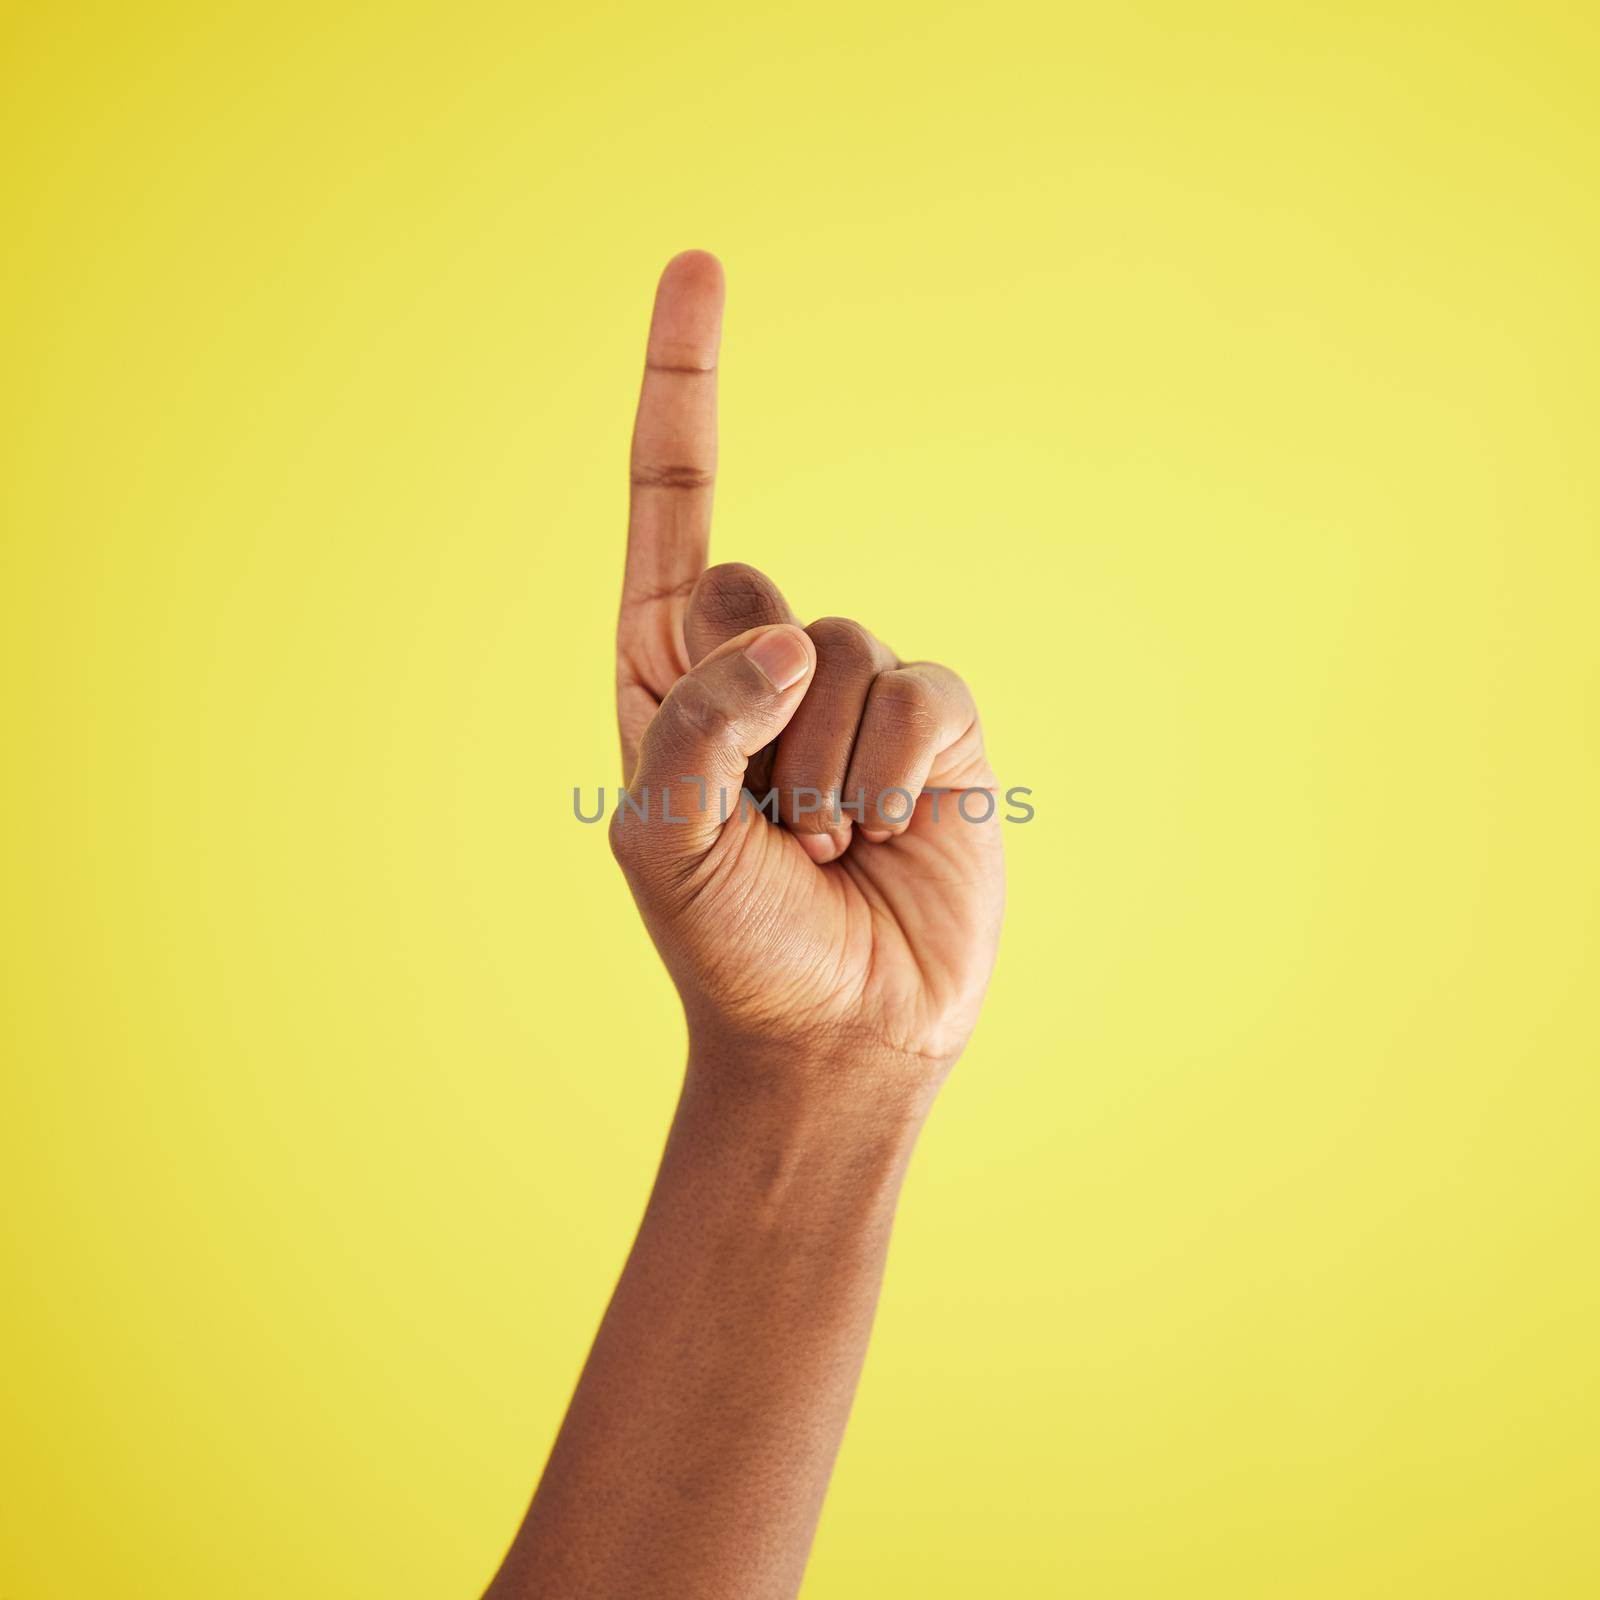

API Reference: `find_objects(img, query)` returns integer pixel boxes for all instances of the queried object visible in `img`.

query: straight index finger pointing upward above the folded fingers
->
[622,250,723,606]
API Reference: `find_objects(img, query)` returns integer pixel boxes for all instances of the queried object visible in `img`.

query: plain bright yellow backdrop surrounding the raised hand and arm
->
[0,0,1600,1600]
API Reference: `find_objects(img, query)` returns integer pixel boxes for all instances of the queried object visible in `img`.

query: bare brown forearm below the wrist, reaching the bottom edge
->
[490,1058,925,1600]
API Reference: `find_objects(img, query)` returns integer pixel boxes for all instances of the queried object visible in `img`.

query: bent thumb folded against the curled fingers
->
[611,624,816,859]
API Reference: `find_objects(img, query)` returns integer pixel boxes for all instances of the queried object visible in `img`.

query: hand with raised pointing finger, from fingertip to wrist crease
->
[611,251,1005,1101]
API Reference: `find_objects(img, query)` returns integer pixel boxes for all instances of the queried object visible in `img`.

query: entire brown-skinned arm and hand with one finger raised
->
[488,251,1003,1600]
